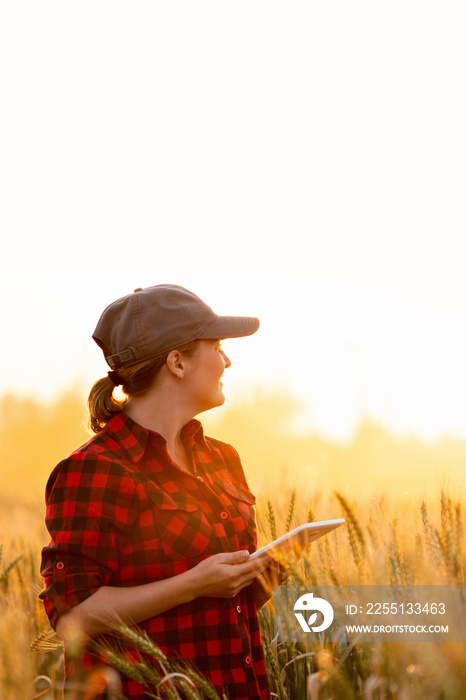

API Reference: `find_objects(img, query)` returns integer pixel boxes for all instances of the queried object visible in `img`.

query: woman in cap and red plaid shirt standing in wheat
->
[41,285,276,700]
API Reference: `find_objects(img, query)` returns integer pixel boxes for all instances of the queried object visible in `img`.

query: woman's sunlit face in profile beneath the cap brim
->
[185,340,231,413]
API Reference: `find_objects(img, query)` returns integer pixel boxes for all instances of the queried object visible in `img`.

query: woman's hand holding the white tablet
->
[189,550,271,598]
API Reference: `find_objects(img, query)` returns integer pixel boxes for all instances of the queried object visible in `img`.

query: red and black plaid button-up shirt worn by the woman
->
[40,413,270,700]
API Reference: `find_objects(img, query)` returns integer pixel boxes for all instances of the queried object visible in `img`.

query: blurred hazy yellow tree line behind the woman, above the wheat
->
[0,387,466,497]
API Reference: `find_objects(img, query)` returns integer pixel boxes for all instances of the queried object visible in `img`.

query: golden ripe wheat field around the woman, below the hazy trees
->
[0,491,466,700]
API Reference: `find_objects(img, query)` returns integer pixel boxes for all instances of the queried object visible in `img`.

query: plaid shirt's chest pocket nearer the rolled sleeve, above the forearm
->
[147,492,216,560]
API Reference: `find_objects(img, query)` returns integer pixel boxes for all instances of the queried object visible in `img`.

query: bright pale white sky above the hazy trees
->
[0,0,466,437]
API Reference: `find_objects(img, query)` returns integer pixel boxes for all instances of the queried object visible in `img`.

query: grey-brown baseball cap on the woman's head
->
[92,284,259,369]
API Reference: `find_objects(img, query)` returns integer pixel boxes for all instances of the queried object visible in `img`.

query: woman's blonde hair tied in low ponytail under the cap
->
[87,340,199,433]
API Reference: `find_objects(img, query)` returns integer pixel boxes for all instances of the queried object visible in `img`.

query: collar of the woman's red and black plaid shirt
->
[105,411,206,463]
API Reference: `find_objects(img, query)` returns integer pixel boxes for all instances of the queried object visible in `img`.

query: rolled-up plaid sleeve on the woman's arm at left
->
[39,452,137,629]
